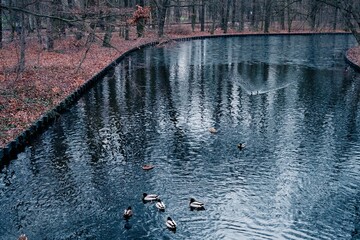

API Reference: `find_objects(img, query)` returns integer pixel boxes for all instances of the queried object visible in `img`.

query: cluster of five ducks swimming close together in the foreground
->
[123,193,205,231]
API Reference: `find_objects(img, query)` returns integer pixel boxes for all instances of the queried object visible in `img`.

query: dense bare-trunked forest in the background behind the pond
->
[0,0,360,53]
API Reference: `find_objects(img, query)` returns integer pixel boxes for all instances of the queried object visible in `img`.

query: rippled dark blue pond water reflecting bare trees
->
[0,35,360,240]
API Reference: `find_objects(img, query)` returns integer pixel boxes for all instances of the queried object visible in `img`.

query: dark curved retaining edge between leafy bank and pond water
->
[0,33,360,169]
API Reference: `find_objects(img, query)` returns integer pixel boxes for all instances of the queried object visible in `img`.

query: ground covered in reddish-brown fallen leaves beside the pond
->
[0,27,360,148]
